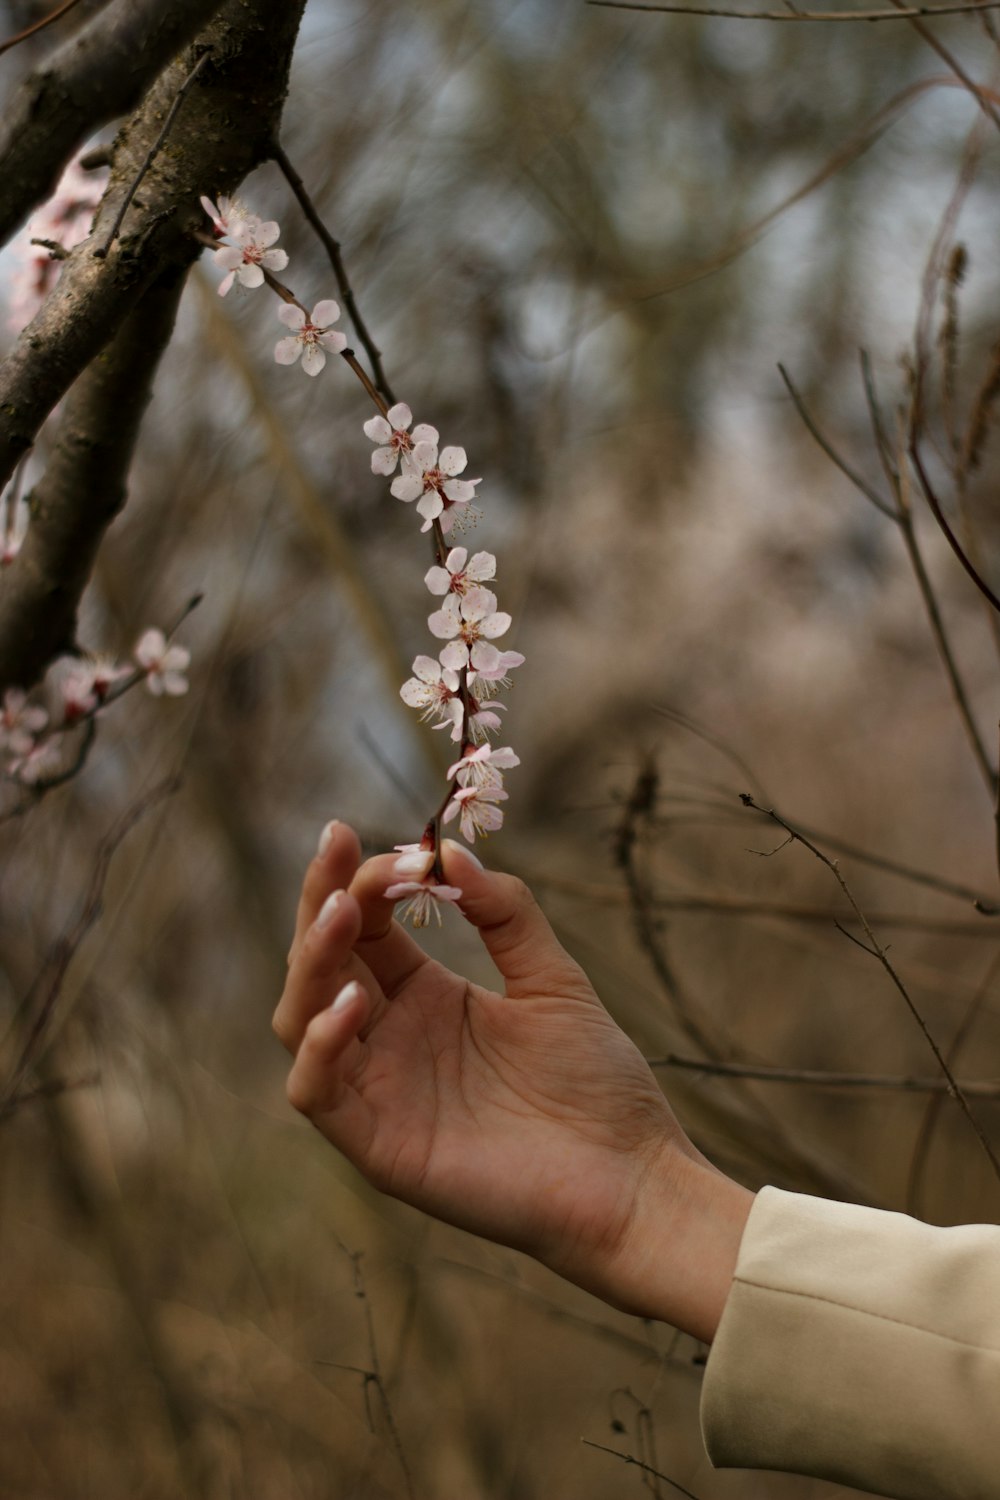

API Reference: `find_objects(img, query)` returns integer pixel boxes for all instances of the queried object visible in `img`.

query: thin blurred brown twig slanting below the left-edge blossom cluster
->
[0,776,180,1119]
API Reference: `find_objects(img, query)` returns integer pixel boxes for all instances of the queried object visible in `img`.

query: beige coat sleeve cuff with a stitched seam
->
[702,1188,1000,1500]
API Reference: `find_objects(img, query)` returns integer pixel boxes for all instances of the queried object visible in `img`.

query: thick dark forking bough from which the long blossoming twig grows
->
[0,0,304,686]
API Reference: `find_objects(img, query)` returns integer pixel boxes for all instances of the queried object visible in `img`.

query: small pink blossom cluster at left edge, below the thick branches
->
[0,630,190,786]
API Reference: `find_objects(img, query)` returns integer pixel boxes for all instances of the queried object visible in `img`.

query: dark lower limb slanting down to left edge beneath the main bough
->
[0,272,184,687]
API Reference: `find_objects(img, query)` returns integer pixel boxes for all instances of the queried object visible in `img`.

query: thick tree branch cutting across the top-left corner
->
[0,0,220,243]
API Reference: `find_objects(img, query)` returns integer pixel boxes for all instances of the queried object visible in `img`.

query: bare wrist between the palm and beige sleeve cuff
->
[606,1139,754,1344]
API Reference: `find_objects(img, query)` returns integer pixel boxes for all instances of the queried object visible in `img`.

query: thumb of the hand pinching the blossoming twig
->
[441,839,594,999]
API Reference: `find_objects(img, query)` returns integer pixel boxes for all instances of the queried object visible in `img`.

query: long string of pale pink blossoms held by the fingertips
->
[201,198,525,927]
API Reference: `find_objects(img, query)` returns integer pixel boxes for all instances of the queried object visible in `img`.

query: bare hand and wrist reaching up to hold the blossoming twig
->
[274,824,753,1343]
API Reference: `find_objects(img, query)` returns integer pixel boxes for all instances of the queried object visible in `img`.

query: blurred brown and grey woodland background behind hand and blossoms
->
[0,0,1000,1500]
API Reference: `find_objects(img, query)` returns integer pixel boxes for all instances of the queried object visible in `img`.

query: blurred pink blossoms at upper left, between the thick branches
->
[7,161,108,333]
